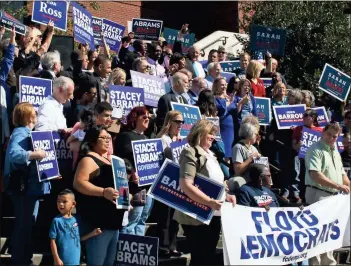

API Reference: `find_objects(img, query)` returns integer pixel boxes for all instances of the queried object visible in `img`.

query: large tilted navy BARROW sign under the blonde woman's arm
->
[149,159,224,224]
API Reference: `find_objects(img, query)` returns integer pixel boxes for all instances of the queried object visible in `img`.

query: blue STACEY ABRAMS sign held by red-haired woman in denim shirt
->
[31,131,60,182]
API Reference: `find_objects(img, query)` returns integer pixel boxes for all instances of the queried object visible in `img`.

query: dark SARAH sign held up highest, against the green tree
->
[250,25,286,56]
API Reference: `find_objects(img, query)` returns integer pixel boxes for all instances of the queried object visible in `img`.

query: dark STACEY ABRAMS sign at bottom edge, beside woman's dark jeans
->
[114,234,159,266]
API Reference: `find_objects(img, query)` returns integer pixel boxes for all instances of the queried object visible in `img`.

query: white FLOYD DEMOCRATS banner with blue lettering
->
[221,195,350,265]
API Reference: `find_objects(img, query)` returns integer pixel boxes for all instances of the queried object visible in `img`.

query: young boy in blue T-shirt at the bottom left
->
[49,189,102,265]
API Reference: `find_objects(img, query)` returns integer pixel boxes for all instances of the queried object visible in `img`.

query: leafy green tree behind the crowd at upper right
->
[239,1,351,92]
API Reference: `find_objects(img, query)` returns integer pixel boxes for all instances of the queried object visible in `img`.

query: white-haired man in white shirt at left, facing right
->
[35,77,74,133]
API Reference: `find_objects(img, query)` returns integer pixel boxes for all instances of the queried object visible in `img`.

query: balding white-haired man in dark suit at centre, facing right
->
[156,72,189,131]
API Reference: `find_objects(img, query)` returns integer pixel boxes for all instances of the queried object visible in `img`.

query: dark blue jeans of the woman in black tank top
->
[85,229,119,266]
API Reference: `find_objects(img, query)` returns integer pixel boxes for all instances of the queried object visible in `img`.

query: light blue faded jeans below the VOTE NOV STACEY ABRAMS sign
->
[121,196,153,236]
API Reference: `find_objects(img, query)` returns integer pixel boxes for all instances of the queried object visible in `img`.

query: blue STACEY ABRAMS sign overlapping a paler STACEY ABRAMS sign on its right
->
[109,85,145,117]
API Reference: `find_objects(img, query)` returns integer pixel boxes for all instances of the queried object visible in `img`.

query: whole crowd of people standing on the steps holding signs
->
[0,19,351,265]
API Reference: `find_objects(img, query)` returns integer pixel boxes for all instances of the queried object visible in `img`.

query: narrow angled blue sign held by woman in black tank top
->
[111,155,129,209]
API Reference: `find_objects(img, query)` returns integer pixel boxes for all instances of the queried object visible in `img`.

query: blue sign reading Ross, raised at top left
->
[32,0,69,31]
